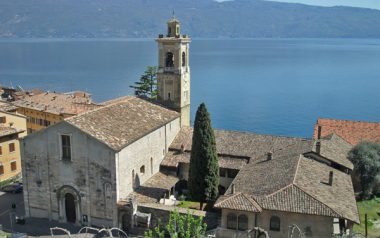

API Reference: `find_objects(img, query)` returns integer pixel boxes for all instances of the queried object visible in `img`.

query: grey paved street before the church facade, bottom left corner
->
[0,192,80,236]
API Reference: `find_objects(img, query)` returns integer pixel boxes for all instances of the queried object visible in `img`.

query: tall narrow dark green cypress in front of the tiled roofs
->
[188,103,219,206]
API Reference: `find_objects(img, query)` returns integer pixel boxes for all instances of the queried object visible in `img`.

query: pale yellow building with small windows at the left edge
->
[0,111,26,181]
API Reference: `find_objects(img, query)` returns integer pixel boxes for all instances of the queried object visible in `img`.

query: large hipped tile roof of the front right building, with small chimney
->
[220,151,359,223]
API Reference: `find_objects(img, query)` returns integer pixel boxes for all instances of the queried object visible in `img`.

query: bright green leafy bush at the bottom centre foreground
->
[144,210,207,238]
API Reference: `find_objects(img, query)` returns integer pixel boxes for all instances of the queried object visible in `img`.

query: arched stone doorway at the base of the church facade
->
[57,185,82,225]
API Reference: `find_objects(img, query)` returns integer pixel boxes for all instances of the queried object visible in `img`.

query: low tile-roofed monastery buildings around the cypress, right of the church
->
[161,127,360,238]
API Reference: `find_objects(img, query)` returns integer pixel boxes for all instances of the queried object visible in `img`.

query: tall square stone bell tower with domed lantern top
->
[156,16,191,126]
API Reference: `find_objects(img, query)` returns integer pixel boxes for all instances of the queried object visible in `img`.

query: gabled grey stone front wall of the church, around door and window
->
[21,122,117,226]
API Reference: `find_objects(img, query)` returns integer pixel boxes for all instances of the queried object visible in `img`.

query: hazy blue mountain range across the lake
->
[0,0,380,38]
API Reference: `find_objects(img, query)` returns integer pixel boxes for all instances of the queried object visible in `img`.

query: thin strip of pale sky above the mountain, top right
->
[271,0,380,10]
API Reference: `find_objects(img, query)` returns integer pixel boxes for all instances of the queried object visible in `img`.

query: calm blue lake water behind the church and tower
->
[0,39,380,137]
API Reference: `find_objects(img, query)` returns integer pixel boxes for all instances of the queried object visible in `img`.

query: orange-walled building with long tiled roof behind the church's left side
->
[12,91,100,134]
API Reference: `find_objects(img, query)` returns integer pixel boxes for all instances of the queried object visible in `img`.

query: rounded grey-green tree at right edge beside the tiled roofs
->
[348,141,380,199]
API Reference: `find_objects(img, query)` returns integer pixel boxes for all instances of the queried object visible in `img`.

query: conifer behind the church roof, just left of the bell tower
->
[130,66,157,99]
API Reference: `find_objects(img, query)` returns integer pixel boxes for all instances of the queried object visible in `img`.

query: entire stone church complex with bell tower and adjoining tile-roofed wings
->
[20,17,359,237]
